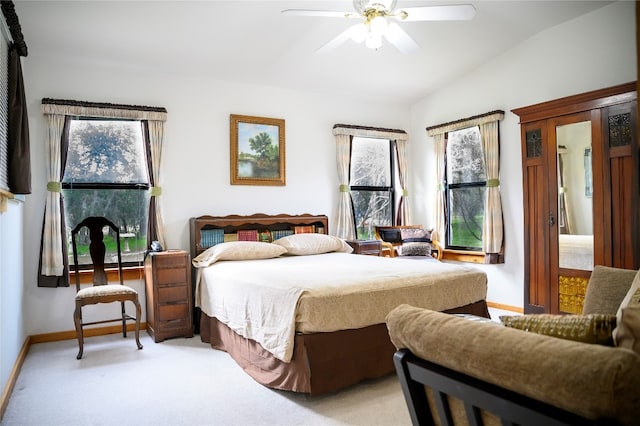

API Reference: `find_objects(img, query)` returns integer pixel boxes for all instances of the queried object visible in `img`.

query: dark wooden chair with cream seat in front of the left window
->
[71,217,142,359]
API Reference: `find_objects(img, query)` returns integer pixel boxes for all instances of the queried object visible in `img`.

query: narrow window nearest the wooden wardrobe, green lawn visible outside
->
[445,126,487,251]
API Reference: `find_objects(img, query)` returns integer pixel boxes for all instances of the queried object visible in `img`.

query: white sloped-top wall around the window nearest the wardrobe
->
[410,1,637,307]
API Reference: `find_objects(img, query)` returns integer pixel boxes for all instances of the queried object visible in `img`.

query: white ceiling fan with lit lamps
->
[282,0,476,53]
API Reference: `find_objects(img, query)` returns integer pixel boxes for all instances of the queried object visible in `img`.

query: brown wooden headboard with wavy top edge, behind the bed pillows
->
[189,213,329,259]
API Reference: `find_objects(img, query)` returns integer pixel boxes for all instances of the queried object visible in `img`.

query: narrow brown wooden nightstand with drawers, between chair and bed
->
[144,250,193,342]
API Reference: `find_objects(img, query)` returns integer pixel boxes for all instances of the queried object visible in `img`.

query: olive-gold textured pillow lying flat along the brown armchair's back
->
[500,314,616,346]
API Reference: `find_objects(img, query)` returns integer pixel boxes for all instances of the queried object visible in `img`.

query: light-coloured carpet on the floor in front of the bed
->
[0,332,411,426]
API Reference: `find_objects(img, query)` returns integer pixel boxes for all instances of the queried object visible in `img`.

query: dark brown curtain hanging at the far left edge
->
[8,44,31,194]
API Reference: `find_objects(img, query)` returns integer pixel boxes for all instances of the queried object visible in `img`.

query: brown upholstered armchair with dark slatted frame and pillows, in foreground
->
[387,266,640,425]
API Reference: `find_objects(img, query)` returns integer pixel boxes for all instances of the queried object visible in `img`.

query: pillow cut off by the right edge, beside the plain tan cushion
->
[613,271,640,353]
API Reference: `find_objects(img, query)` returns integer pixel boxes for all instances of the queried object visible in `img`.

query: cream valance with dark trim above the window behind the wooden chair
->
[42,98,167,121]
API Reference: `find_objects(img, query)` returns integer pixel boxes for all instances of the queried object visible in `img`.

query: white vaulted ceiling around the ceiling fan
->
[14,0,611,105]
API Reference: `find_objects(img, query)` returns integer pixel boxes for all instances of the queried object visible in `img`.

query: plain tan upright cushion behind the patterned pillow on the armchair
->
[582,265,637,315]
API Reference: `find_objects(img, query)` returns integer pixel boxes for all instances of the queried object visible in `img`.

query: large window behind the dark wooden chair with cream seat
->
[62,118,150,265]
